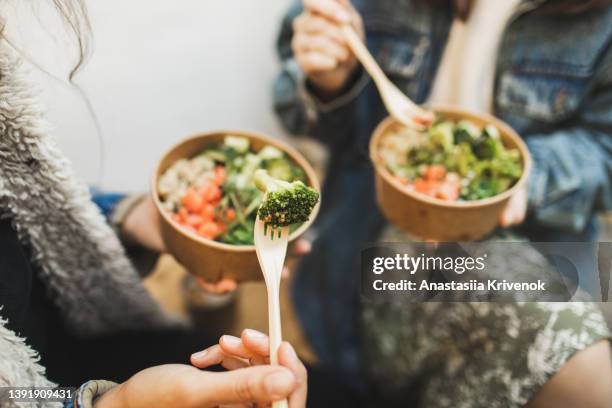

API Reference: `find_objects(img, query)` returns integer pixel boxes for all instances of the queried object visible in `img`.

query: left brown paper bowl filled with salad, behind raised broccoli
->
[153,131,319,281]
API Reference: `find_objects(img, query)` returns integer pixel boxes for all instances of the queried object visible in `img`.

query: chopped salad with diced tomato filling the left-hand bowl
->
[159,135,318,245]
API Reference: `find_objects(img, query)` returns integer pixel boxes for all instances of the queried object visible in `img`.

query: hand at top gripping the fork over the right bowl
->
[291,0,364,97]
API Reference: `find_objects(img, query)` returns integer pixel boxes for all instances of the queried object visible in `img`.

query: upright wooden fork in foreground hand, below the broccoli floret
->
[253,217,289,408]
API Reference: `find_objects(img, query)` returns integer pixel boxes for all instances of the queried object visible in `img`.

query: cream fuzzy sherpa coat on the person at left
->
[0,42,177,387]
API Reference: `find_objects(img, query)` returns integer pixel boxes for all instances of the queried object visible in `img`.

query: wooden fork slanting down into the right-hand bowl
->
[342,25,434,130]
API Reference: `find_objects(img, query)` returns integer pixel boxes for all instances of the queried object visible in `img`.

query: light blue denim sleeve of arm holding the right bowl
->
[526,63,612,232]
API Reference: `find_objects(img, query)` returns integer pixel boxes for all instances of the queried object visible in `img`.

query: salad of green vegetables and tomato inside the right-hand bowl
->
[381,120,523,200]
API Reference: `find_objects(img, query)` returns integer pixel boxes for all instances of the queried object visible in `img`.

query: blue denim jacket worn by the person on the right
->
[274,0,612,380]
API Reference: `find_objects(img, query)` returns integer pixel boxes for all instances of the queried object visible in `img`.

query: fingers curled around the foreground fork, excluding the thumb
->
[191,329,308,408]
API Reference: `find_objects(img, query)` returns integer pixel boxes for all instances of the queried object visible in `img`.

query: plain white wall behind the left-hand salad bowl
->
[2,0,289,191]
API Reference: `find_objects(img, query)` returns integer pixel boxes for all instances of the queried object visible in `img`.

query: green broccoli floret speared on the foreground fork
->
[255,169,319,228]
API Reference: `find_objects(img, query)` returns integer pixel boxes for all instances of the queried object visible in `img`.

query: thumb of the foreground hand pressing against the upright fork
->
[191,366,297,406]
